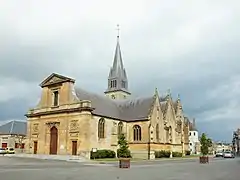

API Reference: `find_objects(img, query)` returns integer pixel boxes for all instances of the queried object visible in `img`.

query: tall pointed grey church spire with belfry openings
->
[105,25,131,99]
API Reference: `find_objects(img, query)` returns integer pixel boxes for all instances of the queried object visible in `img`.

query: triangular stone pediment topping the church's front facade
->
[40,73,75,87]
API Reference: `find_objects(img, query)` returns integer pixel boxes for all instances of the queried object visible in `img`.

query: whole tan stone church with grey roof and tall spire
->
[26,33,189,159]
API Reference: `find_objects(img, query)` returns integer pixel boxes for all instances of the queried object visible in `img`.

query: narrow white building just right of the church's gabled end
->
[189,118,200,154]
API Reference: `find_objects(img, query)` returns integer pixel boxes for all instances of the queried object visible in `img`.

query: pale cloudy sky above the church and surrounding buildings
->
[0,0,240,141]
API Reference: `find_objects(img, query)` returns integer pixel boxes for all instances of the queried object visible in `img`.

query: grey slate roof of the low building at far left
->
[0,121,27,135]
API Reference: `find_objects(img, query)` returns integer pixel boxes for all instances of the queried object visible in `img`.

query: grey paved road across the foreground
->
[0,156,240,180]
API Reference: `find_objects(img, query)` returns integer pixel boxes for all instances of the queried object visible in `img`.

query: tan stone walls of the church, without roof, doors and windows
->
[26,74,189,158]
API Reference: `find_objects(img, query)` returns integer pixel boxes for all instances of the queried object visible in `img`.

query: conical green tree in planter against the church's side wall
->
[117,134,131,158]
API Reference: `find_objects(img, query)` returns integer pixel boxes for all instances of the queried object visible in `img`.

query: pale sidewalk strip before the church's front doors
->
[5,154,89,162]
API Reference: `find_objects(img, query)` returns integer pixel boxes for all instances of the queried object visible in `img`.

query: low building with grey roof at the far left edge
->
[0,121,27,149]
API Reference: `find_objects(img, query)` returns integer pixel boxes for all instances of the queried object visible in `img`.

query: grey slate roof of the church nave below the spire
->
[75,88,155,121]
